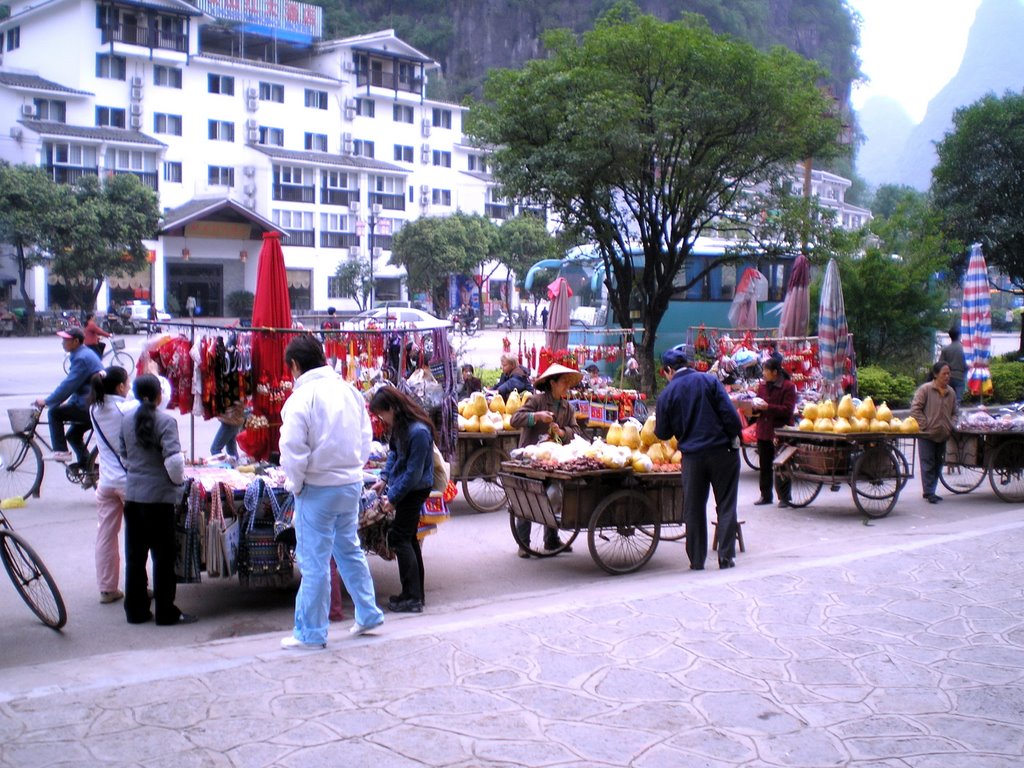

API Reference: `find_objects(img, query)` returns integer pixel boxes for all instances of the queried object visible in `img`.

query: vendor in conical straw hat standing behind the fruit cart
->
[509,362,583,557]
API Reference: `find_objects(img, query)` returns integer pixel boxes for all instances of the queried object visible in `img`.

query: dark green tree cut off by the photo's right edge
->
[932,91,1024,353]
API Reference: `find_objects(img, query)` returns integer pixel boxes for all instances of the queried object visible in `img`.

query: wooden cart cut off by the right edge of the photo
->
[939,429,1024,502]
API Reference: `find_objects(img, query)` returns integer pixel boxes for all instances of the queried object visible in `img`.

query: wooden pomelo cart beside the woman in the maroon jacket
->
[775,428,913,517]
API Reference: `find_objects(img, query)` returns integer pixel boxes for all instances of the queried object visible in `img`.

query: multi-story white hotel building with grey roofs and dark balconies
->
[0,0,514,315]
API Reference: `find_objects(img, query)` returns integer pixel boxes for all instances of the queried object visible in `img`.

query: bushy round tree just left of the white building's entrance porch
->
[49,173,160,308]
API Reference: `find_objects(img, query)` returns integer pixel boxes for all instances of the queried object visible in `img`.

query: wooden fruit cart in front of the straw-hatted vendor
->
[501,462,683,574]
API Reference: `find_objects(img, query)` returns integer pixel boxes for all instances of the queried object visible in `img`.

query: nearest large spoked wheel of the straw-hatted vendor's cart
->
[587,490,662,575]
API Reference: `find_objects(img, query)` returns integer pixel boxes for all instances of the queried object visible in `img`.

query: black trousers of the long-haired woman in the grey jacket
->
[125,502,181,624]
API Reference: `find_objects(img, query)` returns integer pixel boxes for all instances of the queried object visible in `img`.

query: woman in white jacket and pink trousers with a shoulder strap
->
[89,366,137,603]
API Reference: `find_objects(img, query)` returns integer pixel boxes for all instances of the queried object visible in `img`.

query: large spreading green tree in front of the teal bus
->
[466,3,840,392]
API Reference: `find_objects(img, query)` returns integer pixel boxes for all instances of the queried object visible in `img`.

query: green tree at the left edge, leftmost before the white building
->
[0,163,61,334]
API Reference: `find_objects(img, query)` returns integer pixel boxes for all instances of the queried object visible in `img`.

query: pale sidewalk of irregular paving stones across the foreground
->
[0,514,1024,768]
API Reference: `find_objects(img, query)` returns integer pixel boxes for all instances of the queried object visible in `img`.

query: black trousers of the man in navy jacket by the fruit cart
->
[682,447,739,569]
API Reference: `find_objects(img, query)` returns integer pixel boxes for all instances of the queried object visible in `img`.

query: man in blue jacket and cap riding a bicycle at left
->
[36,328,103,464]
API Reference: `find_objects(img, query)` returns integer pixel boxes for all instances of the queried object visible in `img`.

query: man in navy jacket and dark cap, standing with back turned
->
[654,345,741,570]
